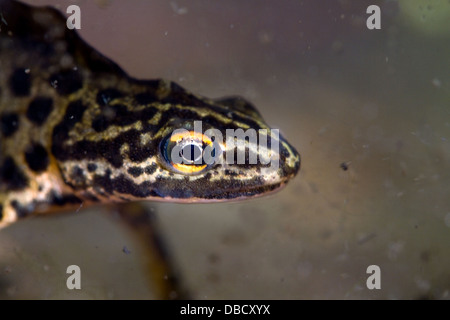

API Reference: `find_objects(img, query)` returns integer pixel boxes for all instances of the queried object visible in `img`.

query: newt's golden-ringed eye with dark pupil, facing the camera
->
[161,130,221,175]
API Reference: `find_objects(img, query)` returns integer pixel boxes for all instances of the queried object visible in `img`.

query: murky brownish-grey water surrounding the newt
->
[0,0,450,299]
